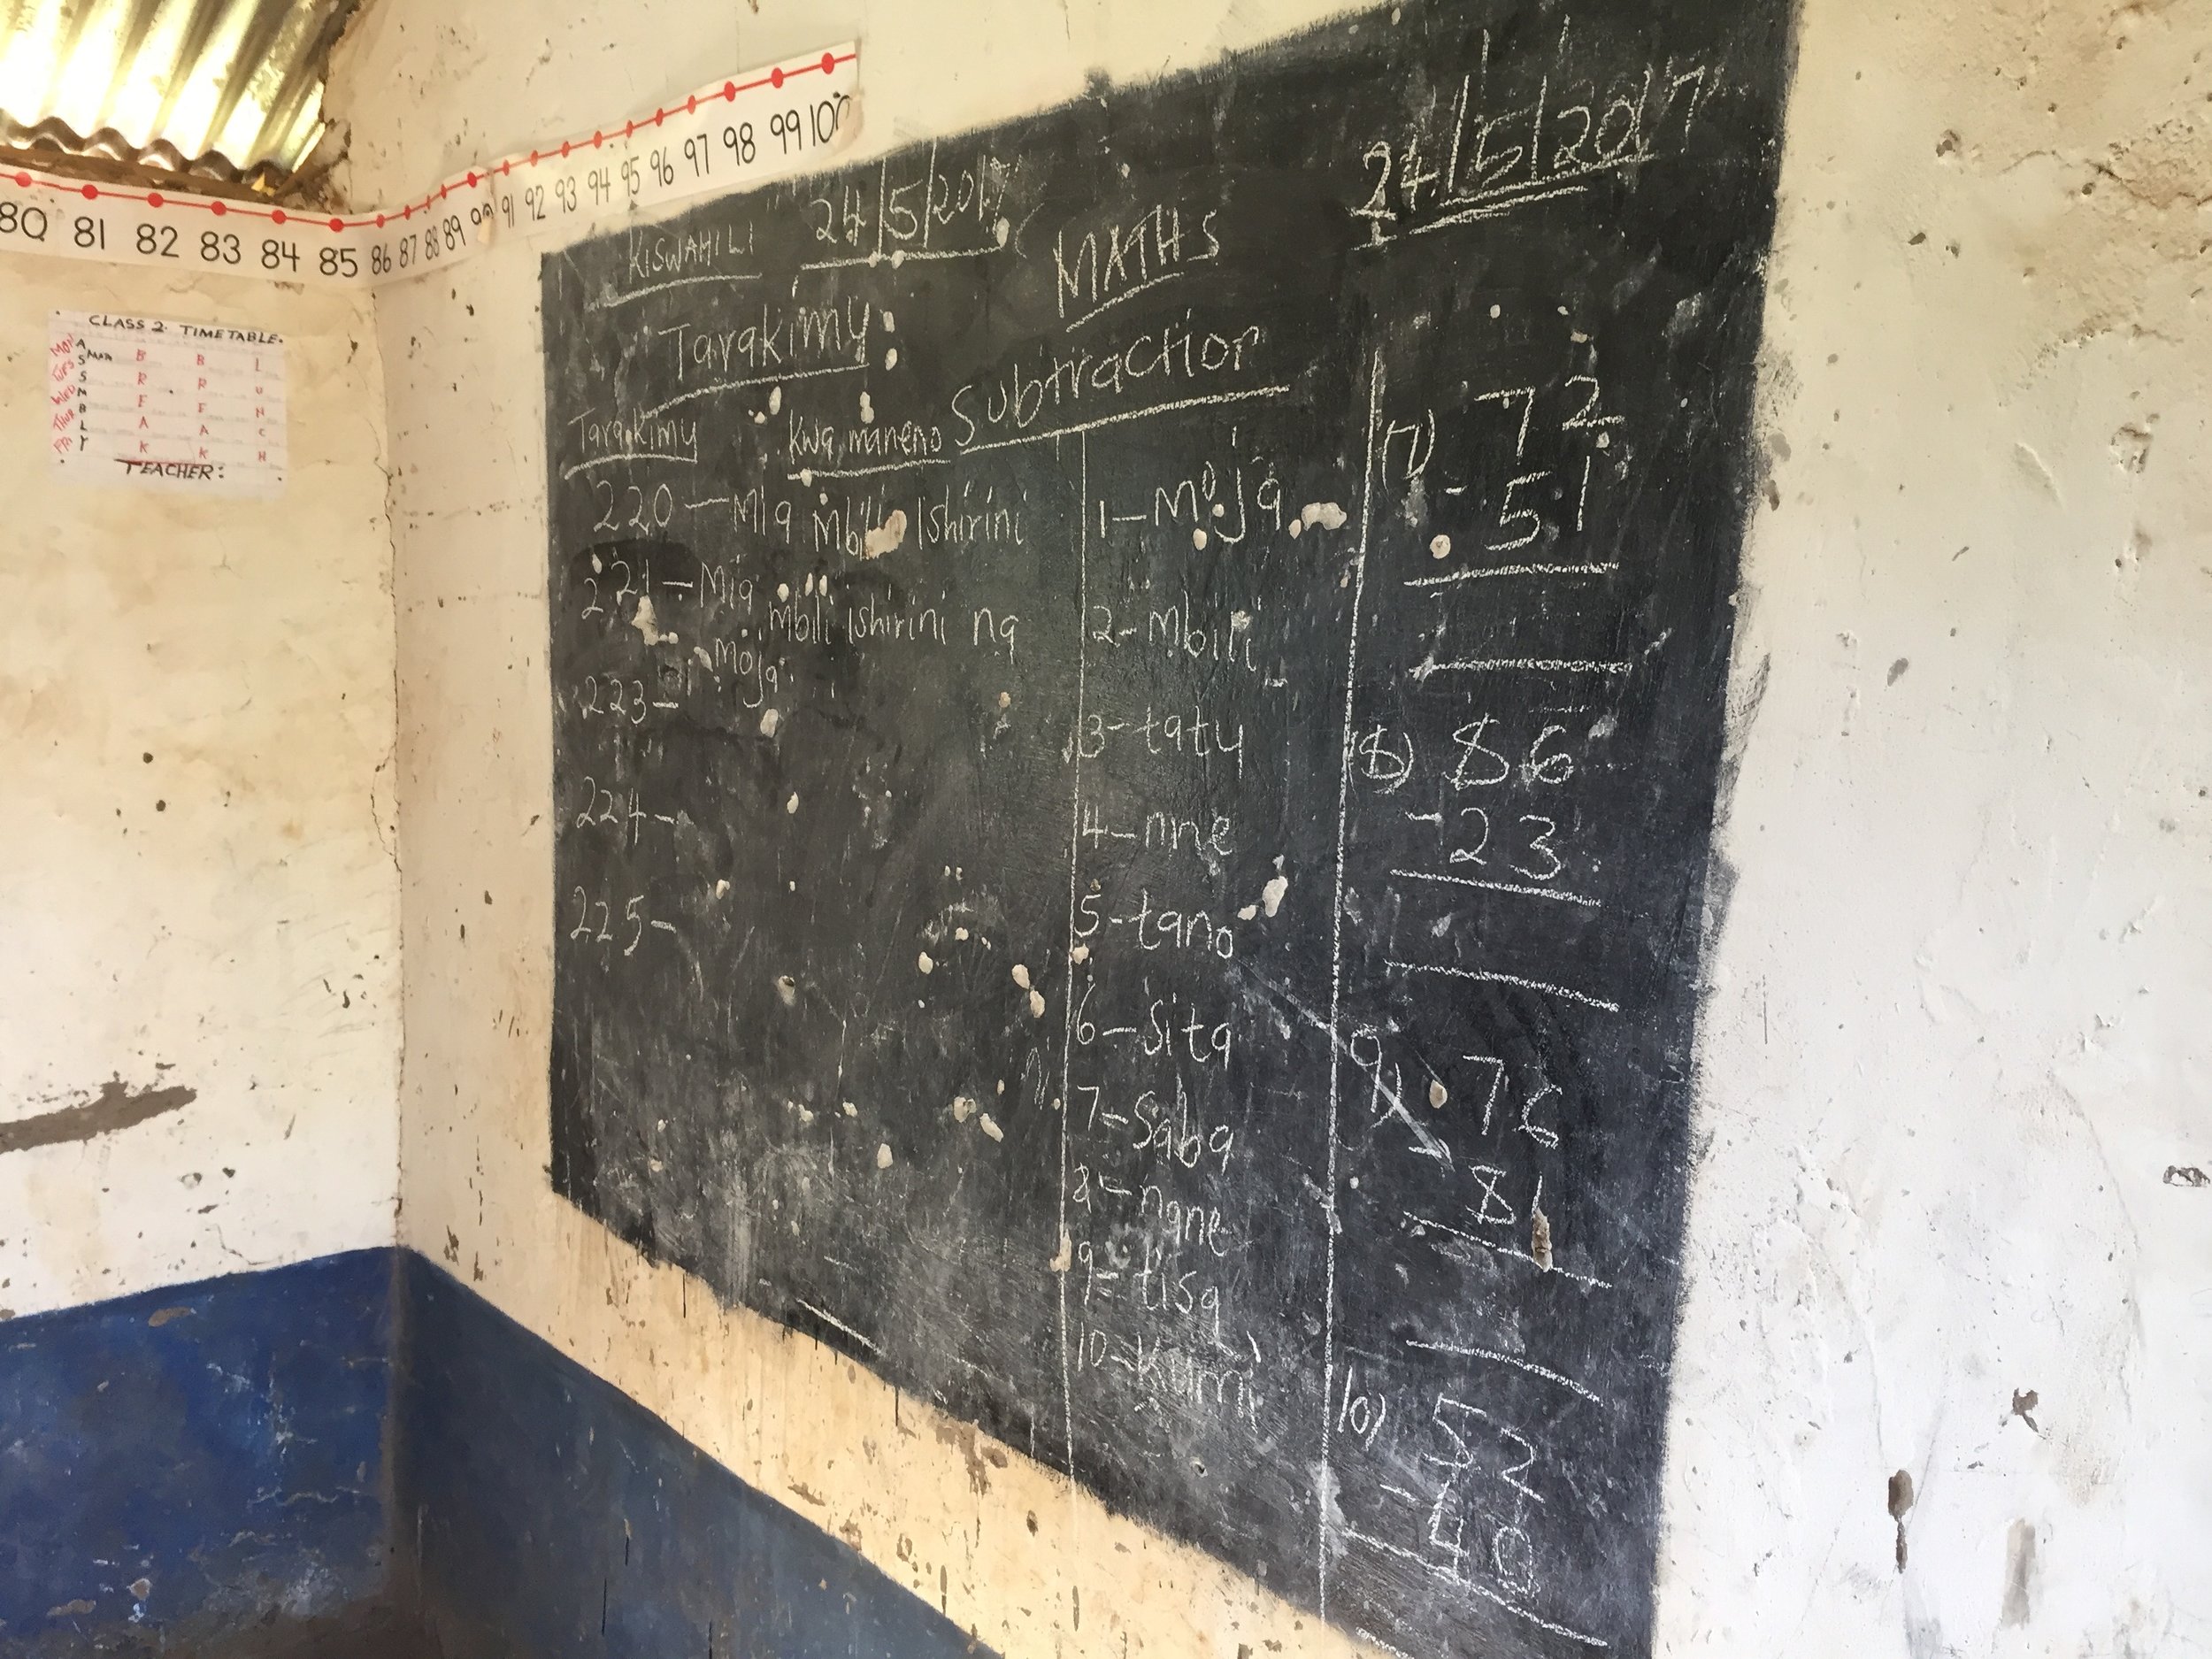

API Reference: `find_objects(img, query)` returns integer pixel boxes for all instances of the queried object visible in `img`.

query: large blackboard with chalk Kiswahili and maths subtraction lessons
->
[544,0,1790,1655]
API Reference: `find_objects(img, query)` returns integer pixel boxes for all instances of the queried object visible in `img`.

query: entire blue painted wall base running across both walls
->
[0,1250,985,1659]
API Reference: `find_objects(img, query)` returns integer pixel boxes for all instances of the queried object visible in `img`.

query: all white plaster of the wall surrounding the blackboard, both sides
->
[332,0,2212,1659]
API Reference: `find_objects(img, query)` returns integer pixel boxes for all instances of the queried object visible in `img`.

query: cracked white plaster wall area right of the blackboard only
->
[1662,0,2212,1659]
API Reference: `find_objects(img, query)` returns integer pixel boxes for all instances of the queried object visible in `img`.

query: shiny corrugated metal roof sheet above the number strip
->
[0,0,354,190]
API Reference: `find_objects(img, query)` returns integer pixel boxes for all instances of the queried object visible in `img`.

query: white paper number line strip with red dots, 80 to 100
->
[0,42,861,288]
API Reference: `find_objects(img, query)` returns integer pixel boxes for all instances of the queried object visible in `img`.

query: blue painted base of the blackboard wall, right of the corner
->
[398,1255,985,1659]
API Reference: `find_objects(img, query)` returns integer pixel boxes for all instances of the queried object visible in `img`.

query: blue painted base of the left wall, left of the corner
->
[0,1250,396,1655]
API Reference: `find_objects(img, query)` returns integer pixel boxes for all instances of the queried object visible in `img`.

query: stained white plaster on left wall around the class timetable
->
[0,255,401,1314]
